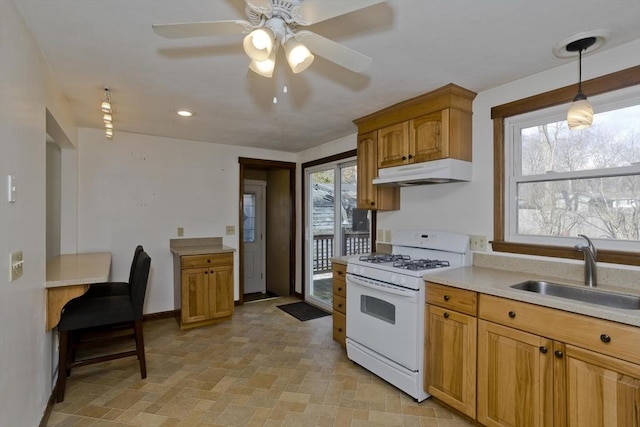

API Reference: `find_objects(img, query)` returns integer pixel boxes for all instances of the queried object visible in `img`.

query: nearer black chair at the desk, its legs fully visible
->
[56,251,151,402]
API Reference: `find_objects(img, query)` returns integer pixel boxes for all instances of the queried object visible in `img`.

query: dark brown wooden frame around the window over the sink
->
[491,66,640,266]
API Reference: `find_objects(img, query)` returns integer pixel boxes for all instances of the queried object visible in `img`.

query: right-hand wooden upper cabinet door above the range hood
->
[409,109,449,163]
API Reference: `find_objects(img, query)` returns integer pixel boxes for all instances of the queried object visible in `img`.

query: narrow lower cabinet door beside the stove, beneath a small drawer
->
[425,304,477,418]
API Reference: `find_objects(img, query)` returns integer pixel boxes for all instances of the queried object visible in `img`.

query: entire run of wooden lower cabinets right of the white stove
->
[425,282,640,427]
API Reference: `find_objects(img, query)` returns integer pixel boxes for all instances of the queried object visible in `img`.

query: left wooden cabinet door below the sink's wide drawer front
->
[477,320,554,427]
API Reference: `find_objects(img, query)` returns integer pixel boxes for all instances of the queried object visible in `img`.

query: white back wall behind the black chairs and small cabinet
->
[78,128,295,313]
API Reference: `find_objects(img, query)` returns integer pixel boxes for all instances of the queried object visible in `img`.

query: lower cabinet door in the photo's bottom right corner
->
[564,345,640,427]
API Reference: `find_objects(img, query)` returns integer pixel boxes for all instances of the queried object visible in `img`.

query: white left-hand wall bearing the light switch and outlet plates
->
[0,1,76,426]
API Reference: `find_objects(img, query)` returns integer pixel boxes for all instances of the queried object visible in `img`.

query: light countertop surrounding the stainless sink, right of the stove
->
[424,266,640,326]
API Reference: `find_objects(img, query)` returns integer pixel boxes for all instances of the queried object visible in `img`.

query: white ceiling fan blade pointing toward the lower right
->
[295,31,373,73]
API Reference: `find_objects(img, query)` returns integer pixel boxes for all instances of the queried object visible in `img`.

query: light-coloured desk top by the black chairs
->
[44,252,111,288]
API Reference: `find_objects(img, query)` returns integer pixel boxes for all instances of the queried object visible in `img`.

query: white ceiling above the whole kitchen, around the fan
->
[14,0,640,152]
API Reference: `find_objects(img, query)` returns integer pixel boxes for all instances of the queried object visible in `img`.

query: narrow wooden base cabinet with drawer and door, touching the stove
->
[424,282,477,418]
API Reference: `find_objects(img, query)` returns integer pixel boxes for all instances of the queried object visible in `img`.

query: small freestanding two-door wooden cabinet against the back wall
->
[174,253,234,329]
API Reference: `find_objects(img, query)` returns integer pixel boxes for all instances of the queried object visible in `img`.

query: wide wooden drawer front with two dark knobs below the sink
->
[479,294,640,364]
